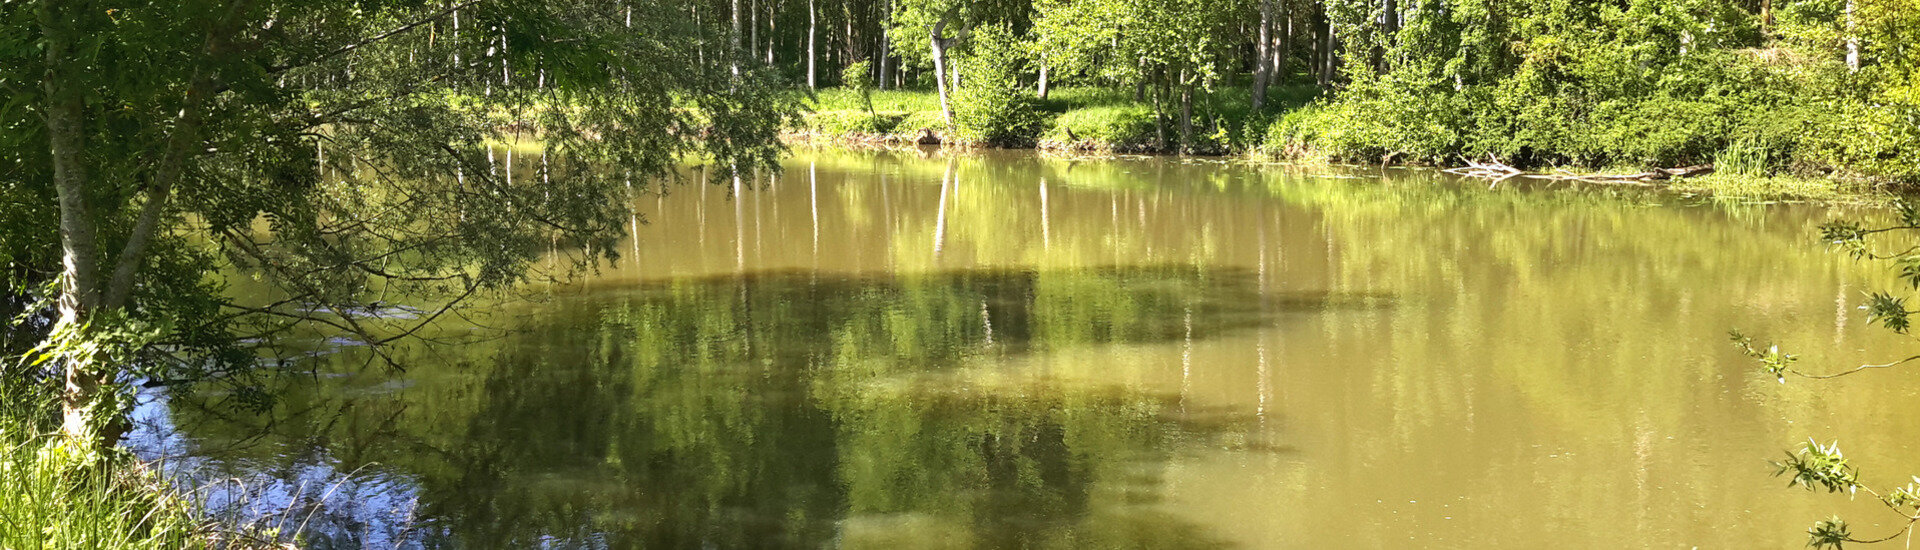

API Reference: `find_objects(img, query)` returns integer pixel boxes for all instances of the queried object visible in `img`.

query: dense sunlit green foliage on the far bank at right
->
[1265,0,1920,181]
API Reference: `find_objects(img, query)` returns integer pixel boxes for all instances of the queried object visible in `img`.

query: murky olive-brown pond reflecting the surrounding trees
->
[132,150,1920,548]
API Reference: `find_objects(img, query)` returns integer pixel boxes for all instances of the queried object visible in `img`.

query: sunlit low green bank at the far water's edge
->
[787,87,1908,202]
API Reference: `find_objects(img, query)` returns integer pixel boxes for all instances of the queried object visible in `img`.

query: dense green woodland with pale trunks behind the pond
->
[744,0,1920,181]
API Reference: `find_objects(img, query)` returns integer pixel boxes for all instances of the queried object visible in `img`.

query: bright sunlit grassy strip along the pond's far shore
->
[793,85,1905,200]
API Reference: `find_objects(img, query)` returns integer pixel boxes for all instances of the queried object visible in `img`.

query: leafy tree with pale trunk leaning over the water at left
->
[0,0,793,442]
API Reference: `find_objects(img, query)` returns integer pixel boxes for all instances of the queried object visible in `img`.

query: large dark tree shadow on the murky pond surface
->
[146,267,1392,548]
